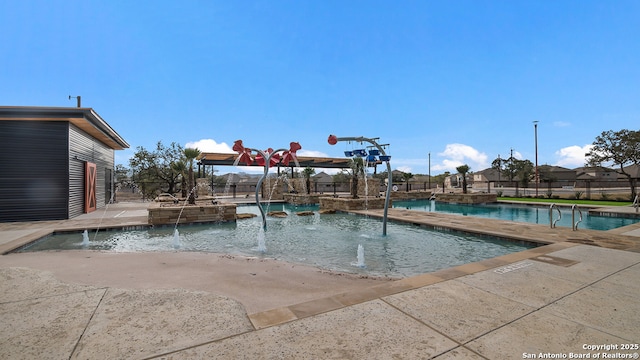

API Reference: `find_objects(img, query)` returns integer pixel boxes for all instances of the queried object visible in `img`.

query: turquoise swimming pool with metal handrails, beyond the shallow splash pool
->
[393,200,640,230]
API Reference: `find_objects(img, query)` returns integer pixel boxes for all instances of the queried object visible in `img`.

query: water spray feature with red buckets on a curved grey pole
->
[233,140,302,231]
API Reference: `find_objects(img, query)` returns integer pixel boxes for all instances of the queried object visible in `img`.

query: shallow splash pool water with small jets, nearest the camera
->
[21,204,533,277]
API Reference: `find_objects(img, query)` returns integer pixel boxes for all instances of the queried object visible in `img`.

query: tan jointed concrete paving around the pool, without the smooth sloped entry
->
[0,201,640,359]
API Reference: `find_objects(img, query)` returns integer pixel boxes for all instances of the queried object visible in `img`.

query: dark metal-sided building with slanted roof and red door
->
[0,106,129,222]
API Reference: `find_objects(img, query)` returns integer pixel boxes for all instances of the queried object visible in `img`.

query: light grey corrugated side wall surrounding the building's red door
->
[69,124,115,217]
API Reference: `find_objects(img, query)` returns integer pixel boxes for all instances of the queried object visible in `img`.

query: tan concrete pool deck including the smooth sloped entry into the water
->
[0,203,640,359]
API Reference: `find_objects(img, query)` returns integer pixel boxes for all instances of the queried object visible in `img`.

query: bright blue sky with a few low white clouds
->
[0,0,640,175]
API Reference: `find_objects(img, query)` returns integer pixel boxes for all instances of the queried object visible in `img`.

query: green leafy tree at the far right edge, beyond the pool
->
[586,129,640,200]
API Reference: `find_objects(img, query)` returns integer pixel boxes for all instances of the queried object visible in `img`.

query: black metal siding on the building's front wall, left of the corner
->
[0,120,69,222]
